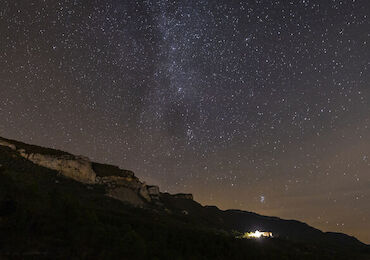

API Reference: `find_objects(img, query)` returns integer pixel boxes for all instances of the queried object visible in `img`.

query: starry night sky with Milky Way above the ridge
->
[0,0,370,243]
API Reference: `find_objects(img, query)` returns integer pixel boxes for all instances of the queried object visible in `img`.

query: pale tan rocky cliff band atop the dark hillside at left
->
[0,137,193,207]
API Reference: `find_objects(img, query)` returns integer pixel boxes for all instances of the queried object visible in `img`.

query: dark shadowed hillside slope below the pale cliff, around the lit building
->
[0,139,370,260]
